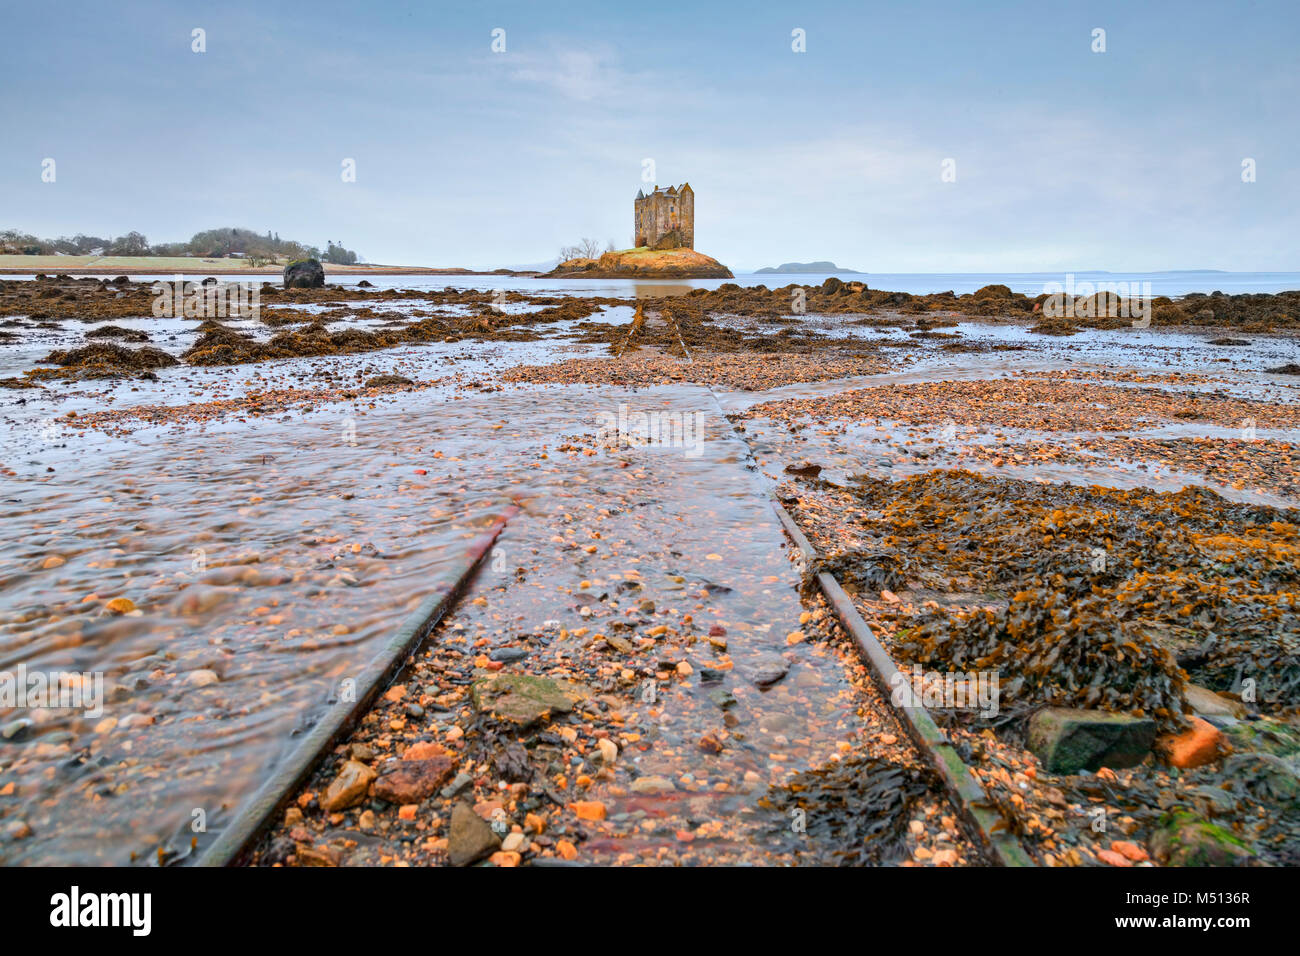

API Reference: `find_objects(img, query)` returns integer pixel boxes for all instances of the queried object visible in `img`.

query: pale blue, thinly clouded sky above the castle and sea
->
[0,0,1300,272]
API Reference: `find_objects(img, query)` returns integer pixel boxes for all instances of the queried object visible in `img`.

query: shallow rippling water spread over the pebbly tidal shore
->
[0,277,1300,864]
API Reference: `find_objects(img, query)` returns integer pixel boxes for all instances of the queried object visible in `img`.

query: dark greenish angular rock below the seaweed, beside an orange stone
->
[1028,708,1156,774]
